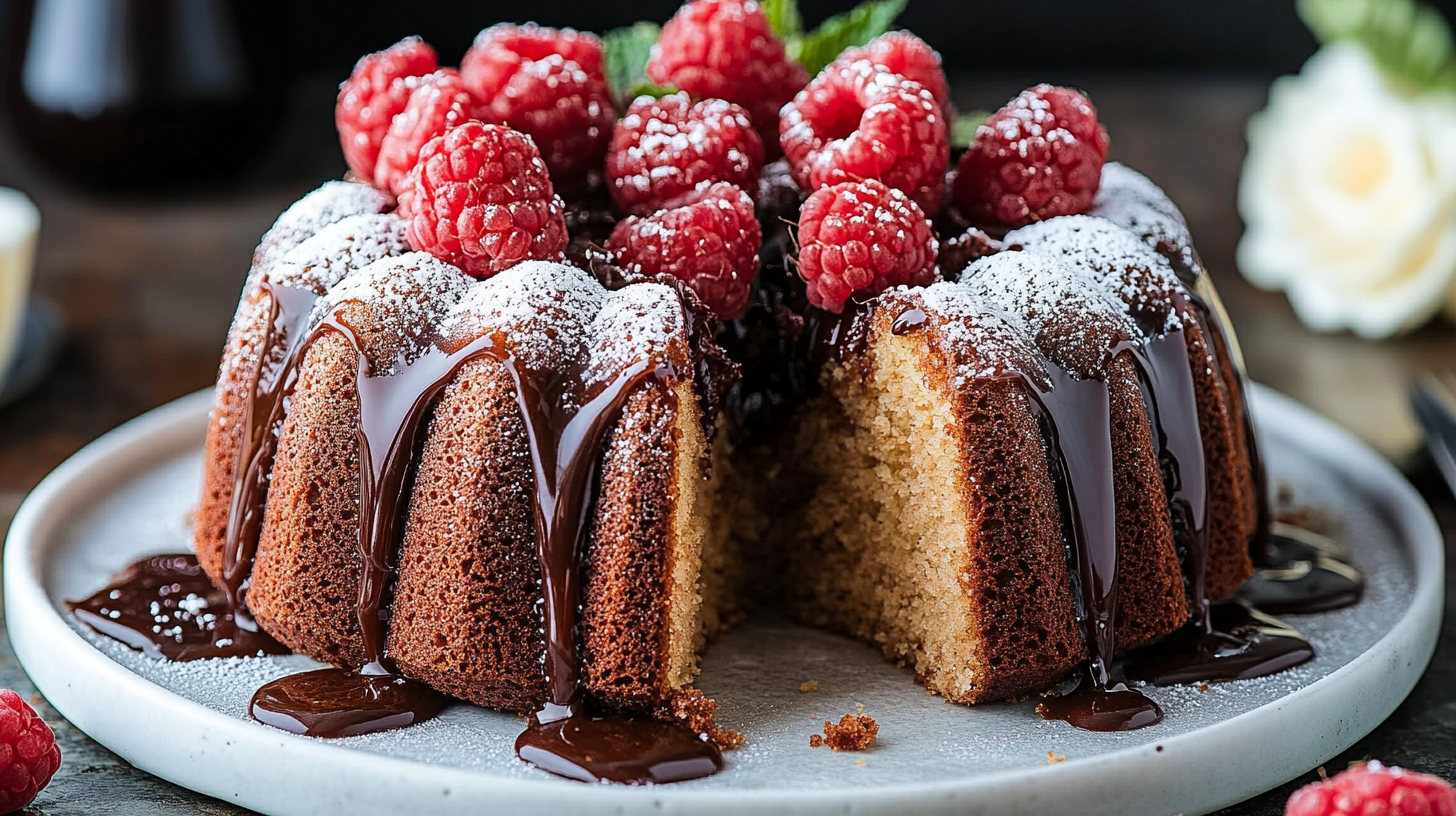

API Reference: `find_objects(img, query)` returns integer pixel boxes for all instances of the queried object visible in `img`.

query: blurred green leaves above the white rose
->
[1299,0,1456,93]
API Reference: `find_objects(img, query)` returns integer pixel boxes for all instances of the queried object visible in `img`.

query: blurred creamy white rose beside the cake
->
[1239,44,1456,338]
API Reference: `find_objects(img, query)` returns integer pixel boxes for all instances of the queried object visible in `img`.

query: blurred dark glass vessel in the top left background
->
[0,0,290,195]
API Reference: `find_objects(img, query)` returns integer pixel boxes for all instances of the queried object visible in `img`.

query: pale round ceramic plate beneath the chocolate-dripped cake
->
[4,389,1443,816]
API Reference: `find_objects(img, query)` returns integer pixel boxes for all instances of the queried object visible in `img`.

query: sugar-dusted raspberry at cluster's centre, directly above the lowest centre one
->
[607,93,763,216]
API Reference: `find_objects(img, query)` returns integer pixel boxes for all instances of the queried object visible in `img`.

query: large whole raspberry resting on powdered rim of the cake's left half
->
[406,119,566,278]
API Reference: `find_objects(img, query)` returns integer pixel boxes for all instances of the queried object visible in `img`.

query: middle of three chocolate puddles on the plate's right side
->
[1124,600,1315,686]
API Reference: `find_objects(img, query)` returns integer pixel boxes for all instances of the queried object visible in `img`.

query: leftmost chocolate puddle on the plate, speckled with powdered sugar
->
[66,552,288,660]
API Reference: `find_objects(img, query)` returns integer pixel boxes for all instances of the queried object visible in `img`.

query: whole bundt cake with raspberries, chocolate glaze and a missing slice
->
[62,0,1357,782]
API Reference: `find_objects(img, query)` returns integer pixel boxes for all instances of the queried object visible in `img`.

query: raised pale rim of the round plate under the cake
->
[3,385,1444,816]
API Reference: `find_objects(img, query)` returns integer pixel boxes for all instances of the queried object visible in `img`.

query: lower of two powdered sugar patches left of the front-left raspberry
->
[265,213,409,294]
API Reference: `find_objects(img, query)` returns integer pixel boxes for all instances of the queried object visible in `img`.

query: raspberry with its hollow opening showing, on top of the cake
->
[779,60,951,216]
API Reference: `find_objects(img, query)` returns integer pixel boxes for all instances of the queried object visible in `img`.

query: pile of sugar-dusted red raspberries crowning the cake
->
[324,0,1108,319]
